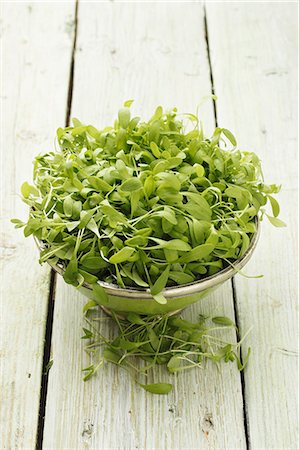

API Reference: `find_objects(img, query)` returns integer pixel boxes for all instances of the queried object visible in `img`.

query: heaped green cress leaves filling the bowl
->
[13,101,284,303]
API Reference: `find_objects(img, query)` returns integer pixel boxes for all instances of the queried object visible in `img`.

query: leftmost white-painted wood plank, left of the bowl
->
[0,2,74,449]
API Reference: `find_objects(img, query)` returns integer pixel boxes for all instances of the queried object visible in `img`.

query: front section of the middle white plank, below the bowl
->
[43,277,246,450]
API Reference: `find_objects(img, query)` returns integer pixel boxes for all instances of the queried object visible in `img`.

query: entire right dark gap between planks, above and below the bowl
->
[203,5,250,449]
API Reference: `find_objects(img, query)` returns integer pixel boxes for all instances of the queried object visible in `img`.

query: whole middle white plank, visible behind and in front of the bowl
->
[44,3,245,450]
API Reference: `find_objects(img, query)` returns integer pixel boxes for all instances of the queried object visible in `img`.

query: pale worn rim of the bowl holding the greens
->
[34,217,261,300]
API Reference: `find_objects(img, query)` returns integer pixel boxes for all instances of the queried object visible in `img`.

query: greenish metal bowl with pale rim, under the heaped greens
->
[36,220,260,315]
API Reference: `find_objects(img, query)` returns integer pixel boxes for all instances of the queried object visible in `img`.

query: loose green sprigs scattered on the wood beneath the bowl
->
[82,301,250,394]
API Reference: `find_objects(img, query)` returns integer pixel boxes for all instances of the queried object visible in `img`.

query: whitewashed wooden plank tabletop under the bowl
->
[0,0,298,450]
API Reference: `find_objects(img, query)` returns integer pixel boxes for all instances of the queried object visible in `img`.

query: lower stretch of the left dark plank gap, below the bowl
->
[36,270,56,450]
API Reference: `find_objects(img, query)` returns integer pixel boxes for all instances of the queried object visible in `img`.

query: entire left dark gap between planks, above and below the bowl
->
[36,0,79,450]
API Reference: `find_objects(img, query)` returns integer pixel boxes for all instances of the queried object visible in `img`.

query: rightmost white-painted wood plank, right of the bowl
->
[207,2,298,449]
